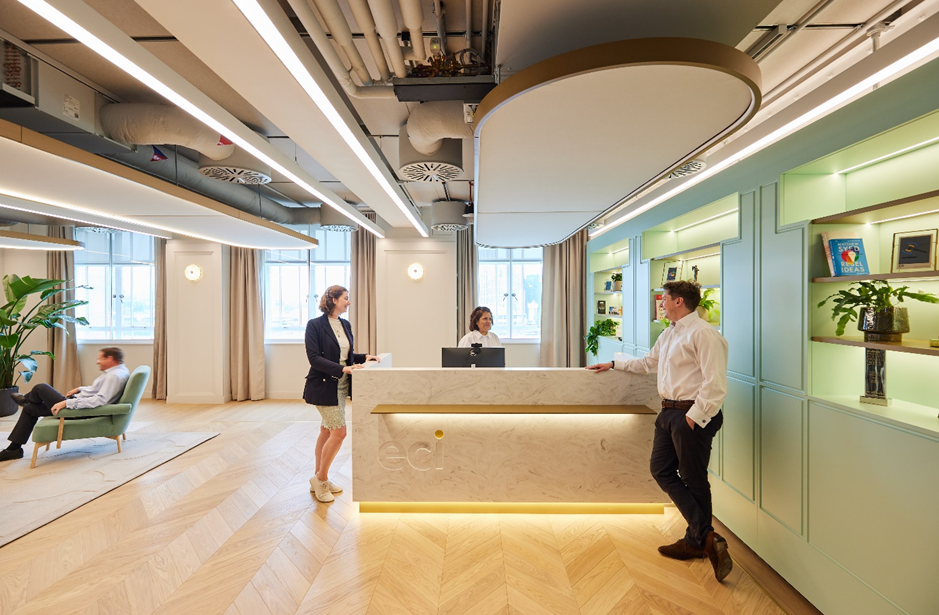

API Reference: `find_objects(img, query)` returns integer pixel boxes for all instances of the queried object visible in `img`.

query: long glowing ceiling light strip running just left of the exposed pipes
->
[232,0,429,237]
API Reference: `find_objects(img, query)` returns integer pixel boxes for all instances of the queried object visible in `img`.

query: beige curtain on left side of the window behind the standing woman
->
[228,248,265,401]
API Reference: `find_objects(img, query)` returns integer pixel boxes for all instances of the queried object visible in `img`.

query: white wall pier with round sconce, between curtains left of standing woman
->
[166,239,231,404]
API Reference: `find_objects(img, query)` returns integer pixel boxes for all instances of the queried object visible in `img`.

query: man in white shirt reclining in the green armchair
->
[0,348,130,461]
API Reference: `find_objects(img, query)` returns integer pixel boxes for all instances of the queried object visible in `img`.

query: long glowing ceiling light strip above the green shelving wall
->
[590,31,939,237]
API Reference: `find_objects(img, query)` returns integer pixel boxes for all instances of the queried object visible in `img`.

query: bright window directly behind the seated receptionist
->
[479,248,541,340]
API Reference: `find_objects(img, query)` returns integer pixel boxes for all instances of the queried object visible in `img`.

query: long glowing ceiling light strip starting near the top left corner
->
[19,0,384,238]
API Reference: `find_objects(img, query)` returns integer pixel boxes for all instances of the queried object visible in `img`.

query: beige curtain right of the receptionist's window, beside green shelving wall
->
[541,230,588,367]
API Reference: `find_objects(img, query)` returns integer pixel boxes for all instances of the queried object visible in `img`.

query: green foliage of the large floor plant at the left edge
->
[0,275,88,389]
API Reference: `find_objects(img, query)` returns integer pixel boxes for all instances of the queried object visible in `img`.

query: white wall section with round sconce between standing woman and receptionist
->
[375,236,457,367]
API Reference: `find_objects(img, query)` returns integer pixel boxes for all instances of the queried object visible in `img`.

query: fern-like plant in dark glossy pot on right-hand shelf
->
[818,280,939,342]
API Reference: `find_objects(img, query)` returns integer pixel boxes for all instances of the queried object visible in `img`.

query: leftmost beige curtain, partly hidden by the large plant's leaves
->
[46,226,82,392]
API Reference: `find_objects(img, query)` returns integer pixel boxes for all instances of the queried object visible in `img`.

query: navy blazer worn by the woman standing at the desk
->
[303,314,365,406]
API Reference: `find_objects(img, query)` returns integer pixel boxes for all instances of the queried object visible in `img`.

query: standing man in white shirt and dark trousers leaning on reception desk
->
[587,281,733,581]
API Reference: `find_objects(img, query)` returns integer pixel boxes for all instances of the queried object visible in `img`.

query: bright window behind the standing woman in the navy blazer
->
[264,225,352,340]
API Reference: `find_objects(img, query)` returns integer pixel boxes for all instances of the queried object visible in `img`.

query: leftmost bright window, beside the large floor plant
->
[75,228,155,340]
